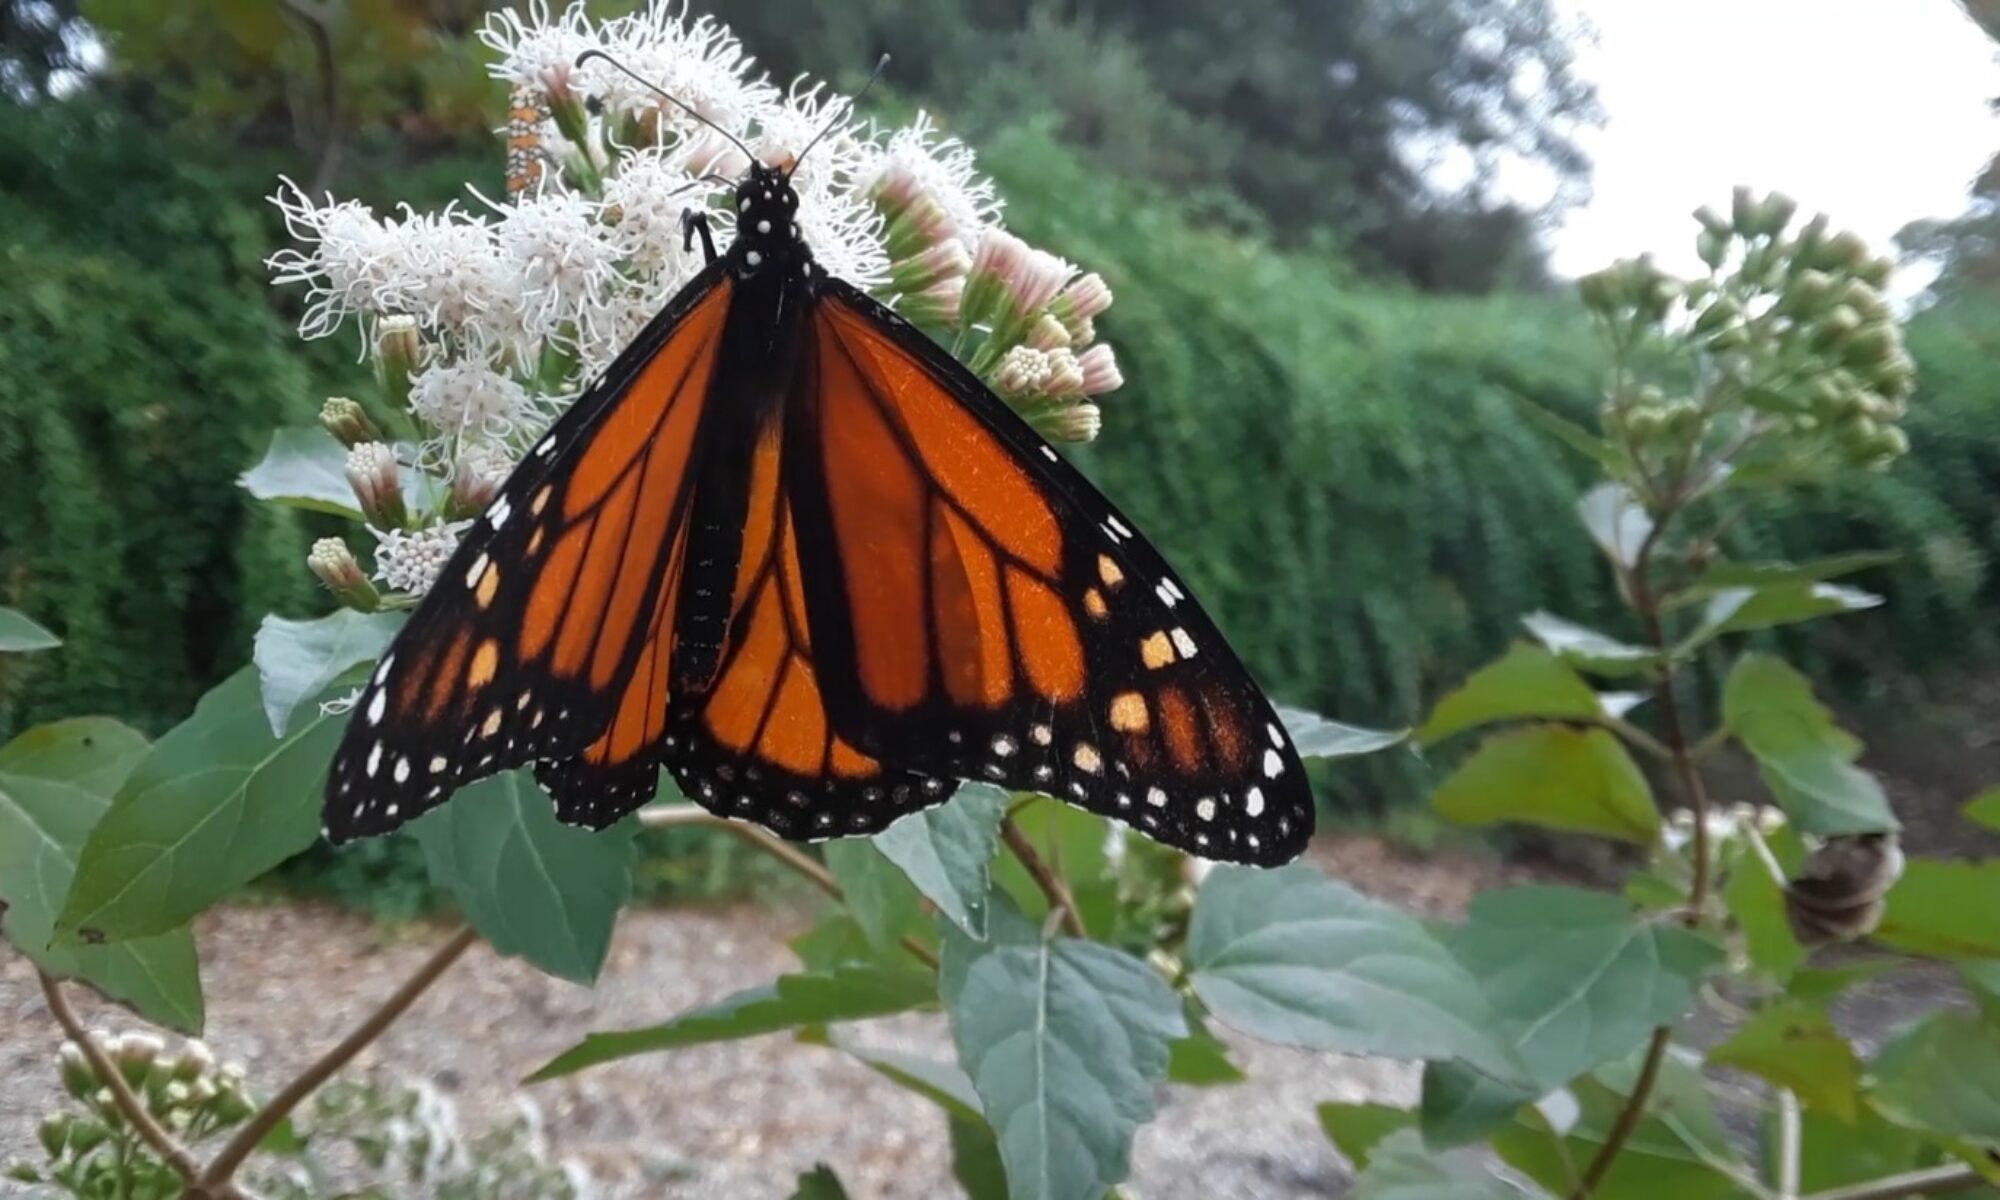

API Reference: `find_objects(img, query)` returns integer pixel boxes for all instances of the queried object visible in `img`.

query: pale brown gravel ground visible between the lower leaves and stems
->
[0,838,1968,1200]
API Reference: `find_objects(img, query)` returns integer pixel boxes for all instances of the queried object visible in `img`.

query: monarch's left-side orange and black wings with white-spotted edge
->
[326,268,732,842]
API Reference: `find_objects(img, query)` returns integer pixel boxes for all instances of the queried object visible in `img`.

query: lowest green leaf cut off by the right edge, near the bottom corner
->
[1868,1012,2000,1142]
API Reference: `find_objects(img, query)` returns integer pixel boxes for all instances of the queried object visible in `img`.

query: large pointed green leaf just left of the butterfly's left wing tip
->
[56,668,346,940]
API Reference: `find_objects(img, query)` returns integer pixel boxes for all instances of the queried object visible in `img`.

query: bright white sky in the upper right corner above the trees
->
[1548,0,2000,292]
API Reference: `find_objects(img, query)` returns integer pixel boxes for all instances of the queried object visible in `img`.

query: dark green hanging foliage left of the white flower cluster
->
[0,106,310,730]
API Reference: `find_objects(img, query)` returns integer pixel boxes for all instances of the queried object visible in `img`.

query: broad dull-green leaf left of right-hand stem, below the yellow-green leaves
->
[1446,886,1722,1094]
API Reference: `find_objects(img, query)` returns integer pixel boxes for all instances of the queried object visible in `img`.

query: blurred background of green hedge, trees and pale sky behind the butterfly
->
[0,0,2000,886]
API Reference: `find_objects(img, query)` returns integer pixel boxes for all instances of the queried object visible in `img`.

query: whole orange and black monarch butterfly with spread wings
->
[326,64,1312,864]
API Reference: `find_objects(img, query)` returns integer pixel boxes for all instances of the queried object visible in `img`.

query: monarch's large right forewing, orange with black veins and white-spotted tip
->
[786,280,1312,862]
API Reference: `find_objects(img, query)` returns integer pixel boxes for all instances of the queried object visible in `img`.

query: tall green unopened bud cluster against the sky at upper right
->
[1578,188,1916,482]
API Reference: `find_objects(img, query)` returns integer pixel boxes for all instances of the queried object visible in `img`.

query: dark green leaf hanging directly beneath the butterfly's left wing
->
[410,770,638,984]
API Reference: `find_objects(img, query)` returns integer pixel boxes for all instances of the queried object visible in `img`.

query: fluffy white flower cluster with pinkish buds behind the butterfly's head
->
[270,0,1120,606]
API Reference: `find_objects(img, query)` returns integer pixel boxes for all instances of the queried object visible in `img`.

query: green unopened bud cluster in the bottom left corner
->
[4,1030,256,1196]
